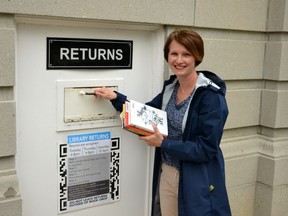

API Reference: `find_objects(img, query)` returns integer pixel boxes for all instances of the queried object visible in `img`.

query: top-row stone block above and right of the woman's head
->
[195,0,269,31]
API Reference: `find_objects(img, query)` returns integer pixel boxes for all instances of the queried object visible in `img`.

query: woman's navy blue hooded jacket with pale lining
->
[111,71,231,216]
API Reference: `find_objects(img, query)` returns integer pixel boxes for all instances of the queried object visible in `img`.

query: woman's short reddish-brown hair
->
[164,29,204,66]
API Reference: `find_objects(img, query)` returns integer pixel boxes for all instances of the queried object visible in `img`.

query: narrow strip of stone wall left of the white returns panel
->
[0,14,21,216]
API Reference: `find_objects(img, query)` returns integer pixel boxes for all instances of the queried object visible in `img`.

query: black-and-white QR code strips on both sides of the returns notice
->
[58,137,121,213]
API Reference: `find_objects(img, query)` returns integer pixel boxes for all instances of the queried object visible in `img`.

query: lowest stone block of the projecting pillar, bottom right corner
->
[255,138,288,216]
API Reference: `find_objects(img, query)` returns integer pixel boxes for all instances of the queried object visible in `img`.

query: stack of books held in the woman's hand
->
[120,100,168,137]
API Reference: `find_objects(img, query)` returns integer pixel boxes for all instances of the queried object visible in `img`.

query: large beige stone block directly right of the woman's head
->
[199,33,265,80]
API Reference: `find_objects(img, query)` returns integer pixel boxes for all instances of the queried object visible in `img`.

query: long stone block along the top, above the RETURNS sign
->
[0,0,195,26]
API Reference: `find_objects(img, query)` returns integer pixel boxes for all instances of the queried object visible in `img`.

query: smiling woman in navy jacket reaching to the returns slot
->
[95,29,231,216]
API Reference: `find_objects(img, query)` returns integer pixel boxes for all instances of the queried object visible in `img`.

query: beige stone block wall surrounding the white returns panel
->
[0,0,288,216]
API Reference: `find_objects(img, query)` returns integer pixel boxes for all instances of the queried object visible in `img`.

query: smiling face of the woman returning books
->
[168,40,195,77]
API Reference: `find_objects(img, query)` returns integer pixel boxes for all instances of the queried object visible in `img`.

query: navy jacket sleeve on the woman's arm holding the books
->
[161,91,228,162]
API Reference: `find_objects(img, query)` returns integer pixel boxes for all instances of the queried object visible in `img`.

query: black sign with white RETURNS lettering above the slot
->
[47,37,133,70]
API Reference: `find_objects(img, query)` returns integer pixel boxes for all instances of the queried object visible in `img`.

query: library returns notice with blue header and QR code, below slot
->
[59,131,119,213]
